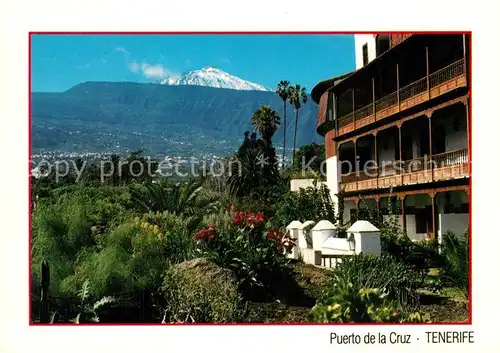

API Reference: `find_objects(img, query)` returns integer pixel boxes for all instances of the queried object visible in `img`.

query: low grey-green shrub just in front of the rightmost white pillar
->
[330,254,422,306]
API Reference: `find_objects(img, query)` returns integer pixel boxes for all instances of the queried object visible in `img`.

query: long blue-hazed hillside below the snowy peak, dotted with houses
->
[31,82,320,155]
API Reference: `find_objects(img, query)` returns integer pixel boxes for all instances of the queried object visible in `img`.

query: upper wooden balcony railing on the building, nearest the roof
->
[334,59,467,136]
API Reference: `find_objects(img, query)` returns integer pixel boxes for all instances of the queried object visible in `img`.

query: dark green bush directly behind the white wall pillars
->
[272,184,337,228]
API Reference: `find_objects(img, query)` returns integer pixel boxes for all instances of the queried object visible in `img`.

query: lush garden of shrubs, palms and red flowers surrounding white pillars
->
[30,98,469,324]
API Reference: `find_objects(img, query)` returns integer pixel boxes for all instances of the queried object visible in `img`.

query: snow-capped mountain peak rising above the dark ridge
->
[158,66,270,91]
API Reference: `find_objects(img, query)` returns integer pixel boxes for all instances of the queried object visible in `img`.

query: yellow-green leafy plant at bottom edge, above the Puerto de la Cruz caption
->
[311,274,429,323]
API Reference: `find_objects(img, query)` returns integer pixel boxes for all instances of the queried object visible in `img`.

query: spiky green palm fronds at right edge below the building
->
[442,232,470,297]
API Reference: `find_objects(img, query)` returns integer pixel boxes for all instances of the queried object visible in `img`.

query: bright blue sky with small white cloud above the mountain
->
[31,34,355,92]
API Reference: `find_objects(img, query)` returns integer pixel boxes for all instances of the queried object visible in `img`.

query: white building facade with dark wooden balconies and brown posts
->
[311,34,470,240]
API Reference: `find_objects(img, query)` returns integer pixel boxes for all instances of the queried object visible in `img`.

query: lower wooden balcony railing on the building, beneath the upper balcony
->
[341,149,470,192]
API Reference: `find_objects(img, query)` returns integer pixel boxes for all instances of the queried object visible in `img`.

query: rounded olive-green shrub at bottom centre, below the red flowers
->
[162,259,241,322]
